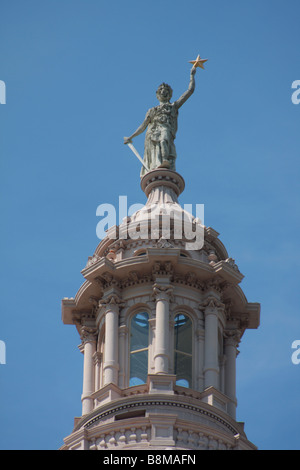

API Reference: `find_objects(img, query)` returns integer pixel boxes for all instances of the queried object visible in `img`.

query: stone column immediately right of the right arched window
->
[203,297,220,389]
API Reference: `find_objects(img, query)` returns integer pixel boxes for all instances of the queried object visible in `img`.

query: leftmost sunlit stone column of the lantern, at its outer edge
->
[81,326,96,415]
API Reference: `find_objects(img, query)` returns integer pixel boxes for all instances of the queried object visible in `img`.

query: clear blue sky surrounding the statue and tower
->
[0,0,300,449]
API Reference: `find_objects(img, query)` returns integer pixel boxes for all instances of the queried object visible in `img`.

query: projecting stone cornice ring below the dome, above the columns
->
[62,248,260,329]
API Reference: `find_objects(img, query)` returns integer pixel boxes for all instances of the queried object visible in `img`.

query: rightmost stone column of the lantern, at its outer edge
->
[224,330,240,419]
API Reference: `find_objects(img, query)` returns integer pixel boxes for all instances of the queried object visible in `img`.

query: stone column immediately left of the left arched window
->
[101,294,121,385]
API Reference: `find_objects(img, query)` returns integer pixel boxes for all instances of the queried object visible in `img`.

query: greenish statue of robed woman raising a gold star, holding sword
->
[124,56,206,176]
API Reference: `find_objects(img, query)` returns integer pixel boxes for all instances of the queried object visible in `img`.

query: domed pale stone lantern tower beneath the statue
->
[62,168,260,451]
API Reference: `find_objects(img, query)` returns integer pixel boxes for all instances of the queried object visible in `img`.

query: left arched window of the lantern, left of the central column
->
[129,312,149,386]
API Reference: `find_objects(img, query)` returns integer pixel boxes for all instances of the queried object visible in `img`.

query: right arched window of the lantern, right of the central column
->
[174,313,192,388]
